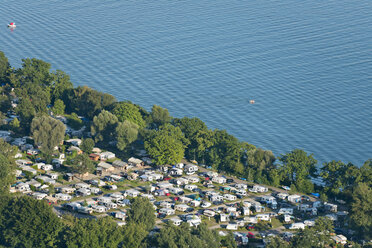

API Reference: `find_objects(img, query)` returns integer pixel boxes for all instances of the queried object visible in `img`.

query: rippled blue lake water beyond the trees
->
[0,0,372,165]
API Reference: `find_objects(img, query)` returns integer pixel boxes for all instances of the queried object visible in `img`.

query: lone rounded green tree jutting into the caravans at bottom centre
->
[127,197,155,231]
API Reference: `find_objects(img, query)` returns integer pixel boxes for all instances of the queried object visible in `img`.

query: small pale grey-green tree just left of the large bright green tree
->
[115,121,138,151]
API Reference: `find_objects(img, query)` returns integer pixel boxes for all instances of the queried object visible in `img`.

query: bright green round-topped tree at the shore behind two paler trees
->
[112,102,146,128]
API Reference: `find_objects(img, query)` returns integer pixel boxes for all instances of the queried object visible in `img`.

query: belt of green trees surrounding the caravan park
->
[0,52,372,247]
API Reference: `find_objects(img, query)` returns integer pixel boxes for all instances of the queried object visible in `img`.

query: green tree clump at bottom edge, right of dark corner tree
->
[60,218,124,248]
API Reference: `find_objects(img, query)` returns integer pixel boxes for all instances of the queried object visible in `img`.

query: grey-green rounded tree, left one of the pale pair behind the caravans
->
[91,110,118,142]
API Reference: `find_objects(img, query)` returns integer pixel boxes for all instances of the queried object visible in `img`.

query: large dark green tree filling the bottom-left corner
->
[0,196,62,248]
